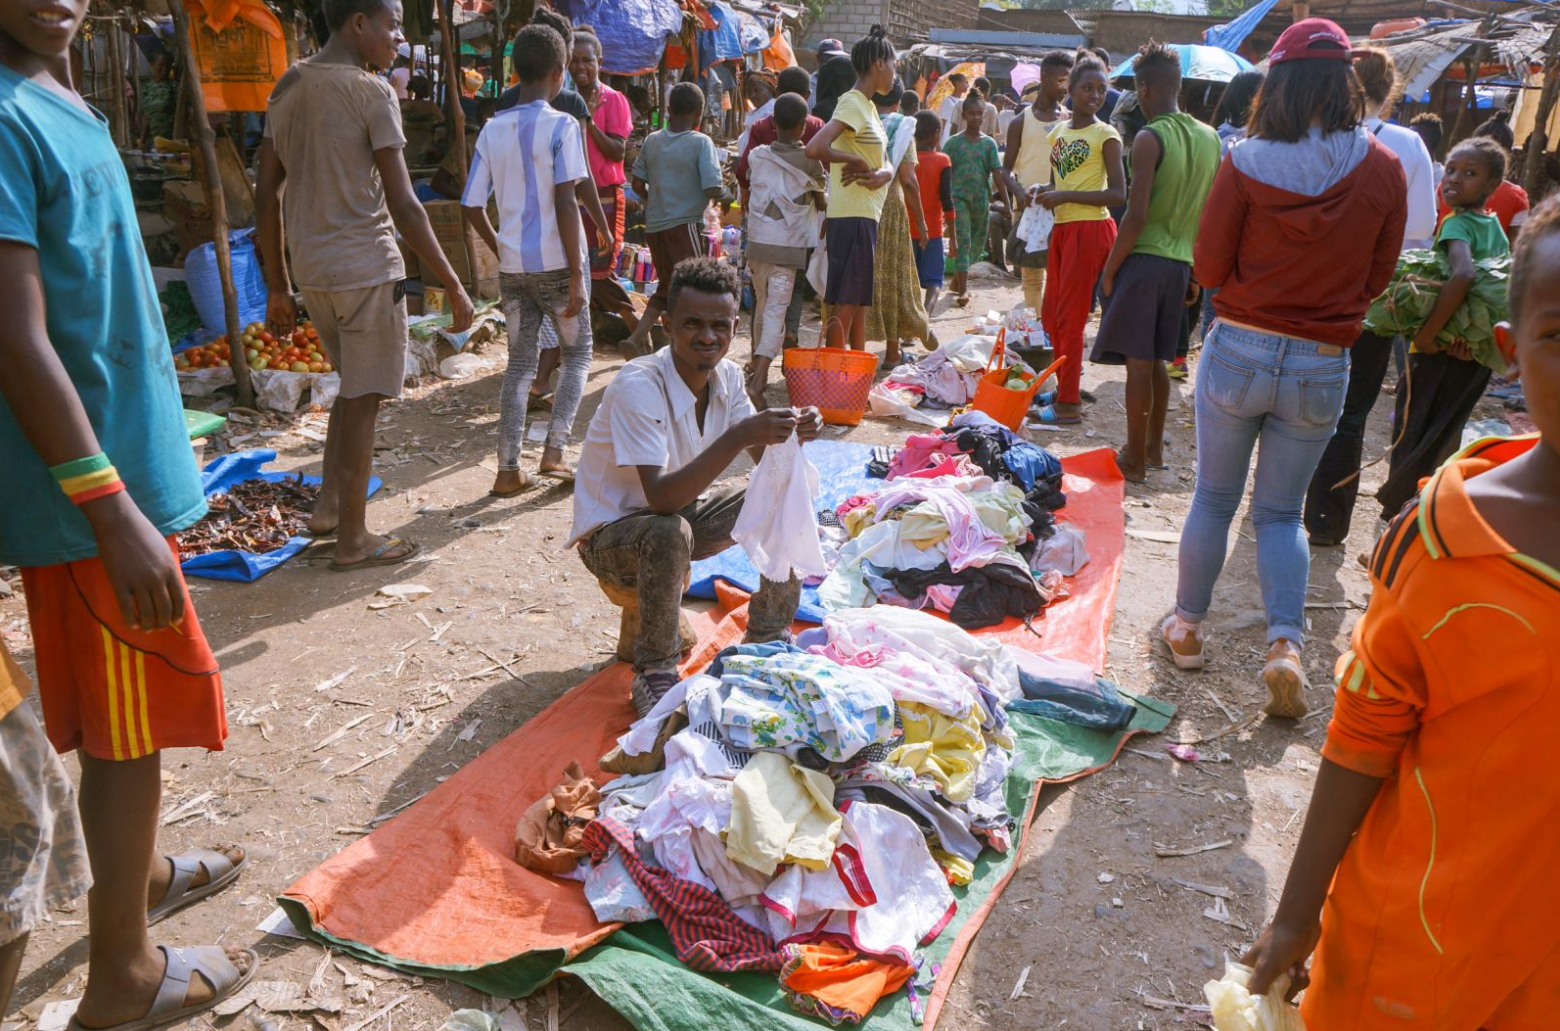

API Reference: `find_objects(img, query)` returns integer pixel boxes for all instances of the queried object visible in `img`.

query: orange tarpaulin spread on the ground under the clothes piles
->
[282,449,1125,1004]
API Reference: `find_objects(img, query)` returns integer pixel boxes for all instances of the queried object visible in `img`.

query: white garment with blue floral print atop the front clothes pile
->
[714,652,894,763]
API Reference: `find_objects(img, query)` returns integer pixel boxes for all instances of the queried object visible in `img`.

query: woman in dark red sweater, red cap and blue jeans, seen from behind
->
[1162,19,1407,717]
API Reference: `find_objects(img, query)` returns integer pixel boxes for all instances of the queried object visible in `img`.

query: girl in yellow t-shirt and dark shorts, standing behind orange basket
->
[807,25,894,351]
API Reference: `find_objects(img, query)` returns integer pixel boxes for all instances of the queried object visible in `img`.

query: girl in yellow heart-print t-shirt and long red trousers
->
[1031,58,1126,424]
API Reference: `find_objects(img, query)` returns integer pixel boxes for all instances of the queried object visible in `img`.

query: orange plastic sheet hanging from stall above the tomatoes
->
[184,0,287,112]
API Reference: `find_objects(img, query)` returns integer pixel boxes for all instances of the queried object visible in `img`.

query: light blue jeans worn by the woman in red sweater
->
[1176,321,1349,646]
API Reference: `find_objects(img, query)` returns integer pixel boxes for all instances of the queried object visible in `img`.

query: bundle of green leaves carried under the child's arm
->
[1365,251,1512,374]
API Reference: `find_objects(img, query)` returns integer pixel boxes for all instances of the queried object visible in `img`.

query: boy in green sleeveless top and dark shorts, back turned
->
[1090,42,1220,482]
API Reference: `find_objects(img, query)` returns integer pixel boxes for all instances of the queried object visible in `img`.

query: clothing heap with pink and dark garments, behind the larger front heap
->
[817,412,1089,630]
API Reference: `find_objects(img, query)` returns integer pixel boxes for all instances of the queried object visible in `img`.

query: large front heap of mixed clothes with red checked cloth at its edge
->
[516,607,1133,1025]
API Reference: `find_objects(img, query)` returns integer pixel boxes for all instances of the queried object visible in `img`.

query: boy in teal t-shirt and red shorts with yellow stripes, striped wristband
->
[0,0,257,1028]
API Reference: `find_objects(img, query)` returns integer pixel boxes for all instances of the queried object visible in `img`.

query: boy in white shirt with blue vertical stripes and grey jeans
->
[460,25,591,498]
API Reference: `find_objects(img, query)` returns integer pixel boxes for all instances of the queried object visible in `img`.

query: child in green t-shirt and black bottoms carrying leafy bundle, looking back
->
[1376,136,1512,519]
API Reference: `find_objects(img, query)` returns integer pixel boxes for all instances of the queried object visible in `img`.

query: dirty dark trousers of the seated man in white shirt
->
[580,487,802,672]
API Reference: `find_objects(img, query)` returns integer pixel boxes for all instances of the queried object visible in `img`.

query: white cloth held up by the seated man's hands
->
[732,434,828,583]
